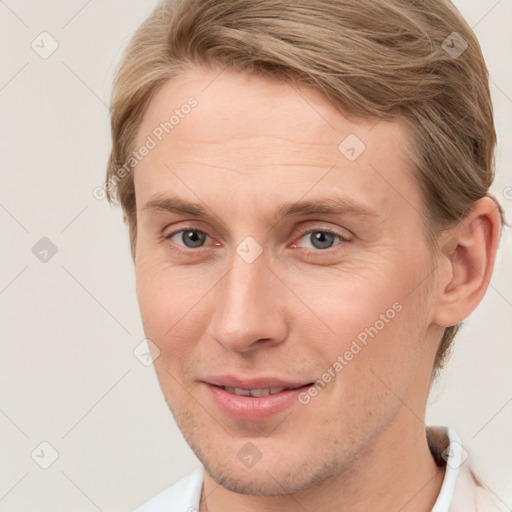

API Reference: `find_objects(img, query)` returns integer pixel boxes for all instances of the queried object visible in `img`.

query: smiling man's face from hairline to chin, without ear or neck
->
[134,69,442,494]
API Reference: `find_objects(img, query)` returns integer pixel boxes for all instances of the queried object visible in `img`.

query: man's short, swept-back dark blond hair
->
[105,0,501,378]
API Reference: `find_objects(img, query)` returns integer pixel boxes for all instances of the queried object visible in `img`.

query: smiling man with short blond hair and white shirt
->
[106,0,501,512]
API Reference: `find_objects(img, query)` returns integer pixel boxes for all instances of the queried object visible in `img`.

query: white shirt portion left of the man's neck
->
[135,468,203,512]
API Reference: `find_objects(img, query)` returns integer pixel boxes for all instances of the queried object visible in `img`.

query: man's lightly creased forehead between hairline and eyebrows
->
[135,68,417,220]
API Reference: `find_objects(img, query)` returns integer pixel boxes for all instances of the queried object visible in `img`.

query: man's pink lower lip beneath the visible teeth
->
[205,383,309,421]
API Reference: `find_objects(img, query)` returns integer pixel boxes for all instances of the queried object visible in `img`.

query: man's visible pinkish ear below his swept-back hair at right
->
[433,197,501,327]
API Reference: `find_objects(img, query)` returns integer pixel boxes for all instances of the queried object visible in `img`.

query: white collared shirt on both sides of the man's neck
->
[135,426,508,512]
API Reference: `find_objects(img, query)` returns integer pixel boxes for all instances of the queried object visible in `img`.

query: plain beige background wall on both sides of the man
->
[0,0,512,512]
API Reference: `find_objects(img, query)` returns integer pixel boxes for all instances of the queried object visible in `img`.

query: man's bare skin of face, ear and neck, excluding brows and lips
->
[134,68,499,512]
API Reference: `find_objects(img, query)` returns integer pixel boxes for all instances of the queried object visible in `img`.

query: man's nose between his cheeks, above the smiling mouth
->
[208,247,287,352]
